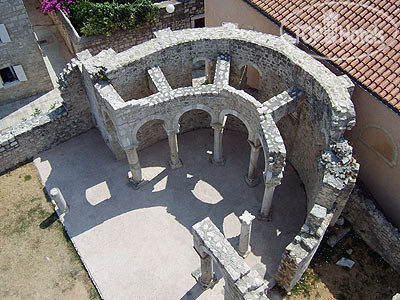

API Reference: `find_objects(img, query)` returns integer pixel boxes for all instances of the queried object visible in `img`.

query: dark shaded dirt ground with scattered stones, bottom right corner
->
[278,224,400,300]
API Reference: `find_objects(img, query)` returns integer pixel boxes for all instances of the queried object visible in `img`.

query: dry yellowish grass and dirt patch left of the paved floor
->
[0,163,100,300]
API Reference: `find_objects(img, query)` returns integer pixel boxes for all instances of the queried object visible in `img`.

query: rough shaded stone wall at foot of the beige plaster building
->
[342,186,400,273]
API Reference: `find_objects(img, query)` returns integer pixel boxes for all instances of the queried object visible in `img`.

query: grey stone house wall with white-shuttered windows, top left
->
[0,0,53,104]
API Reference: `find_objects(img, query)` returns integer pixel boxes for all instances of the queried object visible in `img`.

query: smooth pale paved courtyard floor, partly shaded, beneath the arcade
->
[35,129,306,300]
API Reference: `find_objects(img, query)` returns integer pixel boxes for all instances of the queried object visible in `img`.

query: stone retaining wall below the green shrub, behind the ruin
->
[49,0,204,55]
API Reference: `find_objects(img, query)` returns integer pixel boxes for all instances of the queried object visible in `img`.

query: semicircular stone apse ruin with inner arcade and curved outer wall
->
[70,24,359,290]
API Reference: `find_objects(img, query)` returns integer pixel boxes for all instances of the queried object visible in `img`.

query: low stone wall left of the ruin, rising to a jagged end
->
[0,59,93,173]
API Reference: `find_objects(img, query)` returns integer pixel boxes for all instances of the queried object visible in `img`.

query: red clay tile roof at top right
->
[245,0,400,112]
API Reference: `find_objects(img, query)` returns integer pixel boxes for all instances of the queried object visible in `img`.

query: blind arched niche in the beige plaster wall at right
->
[359,124,399,167]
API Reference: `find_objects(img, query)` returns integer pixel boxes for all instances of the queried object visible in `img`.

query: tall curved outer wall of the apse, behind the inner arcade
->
[90,27,358,213]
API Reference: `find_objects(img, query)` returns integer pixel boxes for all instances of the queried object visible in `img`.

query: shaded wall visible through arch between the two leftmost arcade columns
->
[136,119,168,150]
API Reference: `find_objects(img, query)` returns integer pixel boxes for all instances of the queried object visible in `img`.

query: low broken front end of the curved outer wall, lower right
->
[275,204,333,291]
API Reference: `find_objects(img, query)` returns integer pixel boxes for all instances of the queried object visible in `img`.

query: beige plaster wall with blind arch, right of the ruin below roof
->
[347,86,400,228]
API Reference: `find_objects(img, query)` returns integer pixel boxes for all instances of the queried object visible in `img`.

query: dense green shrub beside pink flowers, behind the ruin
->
[71,0,158,36]
